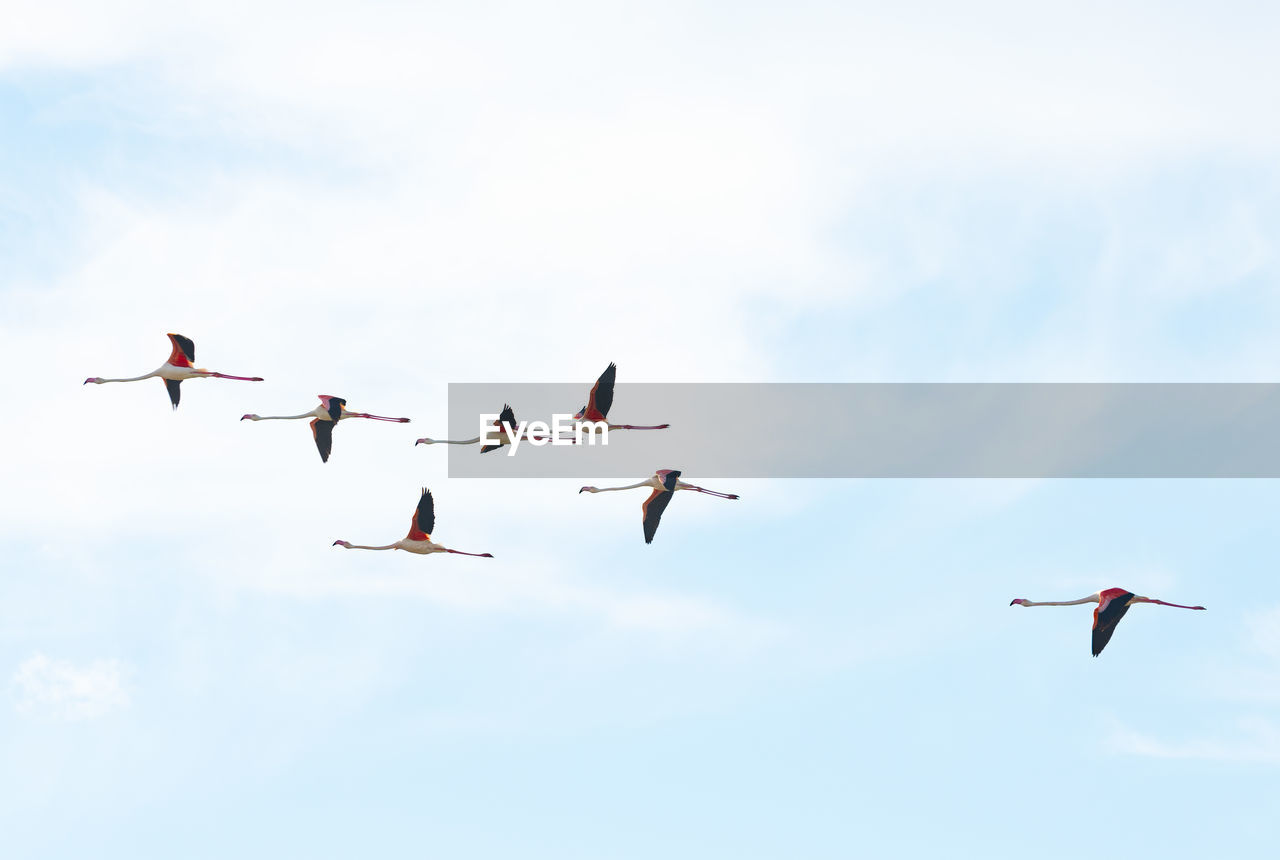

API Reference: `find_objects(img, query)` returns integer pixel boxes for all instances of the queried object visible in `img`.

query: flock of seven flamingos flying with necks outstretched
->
[84,334,1204,657]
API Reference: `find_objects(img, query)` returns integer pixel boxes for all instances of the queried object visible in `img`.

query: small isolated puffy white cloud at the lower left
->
[13,654,129,722]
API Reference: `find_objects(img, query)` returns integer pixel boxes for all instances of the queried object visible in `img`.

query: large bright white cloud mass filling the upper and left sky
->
[0,0,1277,647]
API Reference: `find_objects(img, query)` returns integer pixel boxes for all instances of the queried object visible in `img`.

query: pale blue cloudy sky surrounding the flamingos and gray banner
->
[0,0,1280,860]
